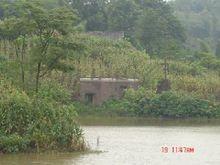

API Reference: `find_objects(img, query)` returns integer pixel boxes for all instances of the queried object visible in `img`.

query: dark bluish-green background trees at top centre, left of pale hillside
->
[70,0,185,56]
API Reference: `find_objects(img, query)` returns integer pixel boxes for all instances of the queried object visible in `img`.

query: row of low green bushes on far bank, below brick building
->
[77,88,220,118]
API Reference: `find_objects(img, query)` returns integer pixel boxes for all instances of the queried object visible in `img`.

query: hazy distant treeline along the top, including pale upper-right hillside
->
[0,0,220,58]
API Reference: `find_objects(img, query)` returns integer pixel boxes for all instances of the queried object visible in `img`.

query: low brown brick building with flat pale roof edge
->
[80,78,138,105]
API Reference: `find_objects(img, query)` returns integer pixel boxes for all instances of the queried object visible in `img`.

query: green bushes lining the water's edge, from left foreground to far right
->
[0,79,220,153]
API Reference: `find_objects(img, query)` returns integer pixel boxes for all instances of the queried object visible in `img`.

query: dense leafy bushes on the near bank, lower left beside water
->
[0,79,85,153]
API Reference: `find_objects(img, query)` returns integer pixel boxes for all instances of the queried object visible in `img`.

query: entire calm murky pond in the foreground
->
[0,119,220,165]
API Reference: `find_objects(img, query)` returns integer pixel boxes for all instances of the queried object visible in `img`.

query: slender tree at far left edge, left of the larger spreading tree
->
[0,1,34,90]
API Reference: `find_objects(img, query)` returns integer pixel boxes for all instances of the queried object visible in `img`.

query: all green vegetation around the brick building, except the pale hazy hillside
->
[0,0,220,153]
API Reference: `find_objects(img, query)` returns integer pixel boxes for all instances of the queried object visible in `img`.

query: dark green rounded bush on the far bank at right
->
[144,92,219,118]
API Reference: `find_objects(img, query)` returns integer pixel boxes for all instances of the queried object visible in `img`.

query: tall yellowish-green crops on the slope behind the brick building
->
[52,34,220,101]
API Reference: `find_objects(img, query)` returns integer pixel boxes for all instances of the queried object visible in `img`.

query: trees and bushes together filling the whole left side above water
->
[0,1,86,153]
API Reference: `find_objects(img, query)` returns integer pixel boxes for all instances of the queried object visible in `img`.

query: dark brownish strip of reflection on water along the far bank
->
[78,117,220,127]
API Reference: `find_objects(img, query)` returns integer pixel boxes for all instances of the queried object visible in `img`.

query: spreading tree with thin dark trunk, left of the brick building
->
[22,2,76,92]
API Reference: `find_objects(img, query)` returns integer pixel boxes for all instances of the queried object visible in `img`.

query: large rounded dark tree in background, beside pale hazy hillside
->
[135,6,185,56]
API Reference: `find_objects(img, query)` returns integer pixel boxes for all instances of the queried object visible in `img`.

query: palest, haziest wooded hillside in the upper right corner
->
[170,0,220,52]
